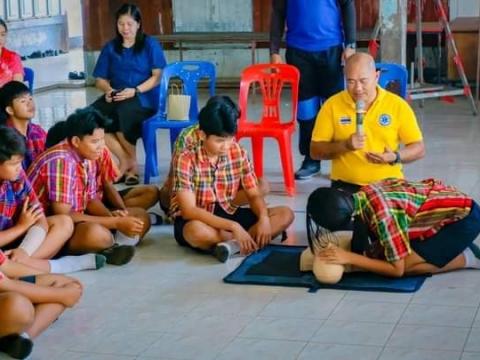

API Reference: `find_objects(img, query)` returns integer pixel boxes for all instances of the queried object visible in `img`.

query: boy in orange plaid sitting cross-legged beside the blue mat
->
[170,96,294,262]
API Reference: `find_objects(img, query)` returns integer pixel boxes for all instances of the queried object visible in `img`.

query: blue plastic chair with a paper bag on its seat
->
[142,61,216,184]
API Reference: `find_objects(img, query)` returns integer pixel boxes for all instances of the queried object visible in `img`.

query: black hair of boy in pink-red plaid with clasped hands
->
[64,106,111,139]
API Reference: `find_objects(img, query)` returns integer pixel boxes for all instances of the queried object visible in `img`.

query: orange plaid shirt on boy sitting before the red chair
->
[170,142,257,217]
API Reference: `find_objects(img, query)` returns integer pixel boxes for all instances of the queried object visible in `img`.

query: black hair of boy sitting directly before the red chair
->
[198,96,240,137]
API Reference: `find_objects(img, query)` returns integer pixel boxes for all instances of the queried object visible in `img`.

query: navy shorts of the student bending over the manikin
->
[410,202,480,268]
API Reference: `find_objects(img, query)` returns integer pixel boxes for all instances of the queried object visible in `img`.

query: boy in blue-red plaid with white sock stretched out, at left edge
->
[0,126,105,273]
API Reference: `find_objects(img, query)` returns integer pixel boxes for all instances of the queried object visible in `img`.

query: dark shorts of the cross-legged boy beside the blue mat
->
[173,204,258,253]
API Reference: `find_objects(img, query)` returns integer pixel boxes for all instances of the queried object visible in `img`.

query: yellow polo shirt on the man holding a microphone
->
[312,86,422,185]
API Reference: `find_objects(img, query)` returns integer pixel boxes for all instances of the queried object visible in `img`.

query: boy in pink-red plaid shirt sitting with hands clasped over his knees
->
[28,107,148,265]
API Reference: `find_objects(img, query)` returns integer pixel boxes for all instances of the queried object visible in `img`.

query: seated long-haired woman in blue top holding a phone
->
[92,4,166,185]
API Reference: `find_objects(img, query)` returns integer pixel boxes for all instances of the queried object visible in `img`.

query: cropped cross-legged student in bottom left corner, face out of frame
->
[0,250,83,359]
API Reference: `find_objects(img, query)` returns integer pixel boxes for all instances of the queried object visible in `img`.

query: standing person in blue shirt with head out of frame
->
[270,0,356,180]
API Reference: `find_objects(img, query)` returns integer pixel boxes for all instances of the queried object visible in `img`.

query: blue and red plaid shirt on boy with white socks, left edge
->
[0,170,39,231]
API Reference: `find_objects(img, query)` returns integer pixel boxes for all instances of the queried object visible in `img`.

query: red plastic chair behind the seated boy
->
[236,64,300,196]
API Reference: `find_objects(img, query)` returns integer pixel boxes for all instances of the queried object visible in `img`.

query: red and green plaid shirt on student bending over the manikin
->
[353,179,472,262]
